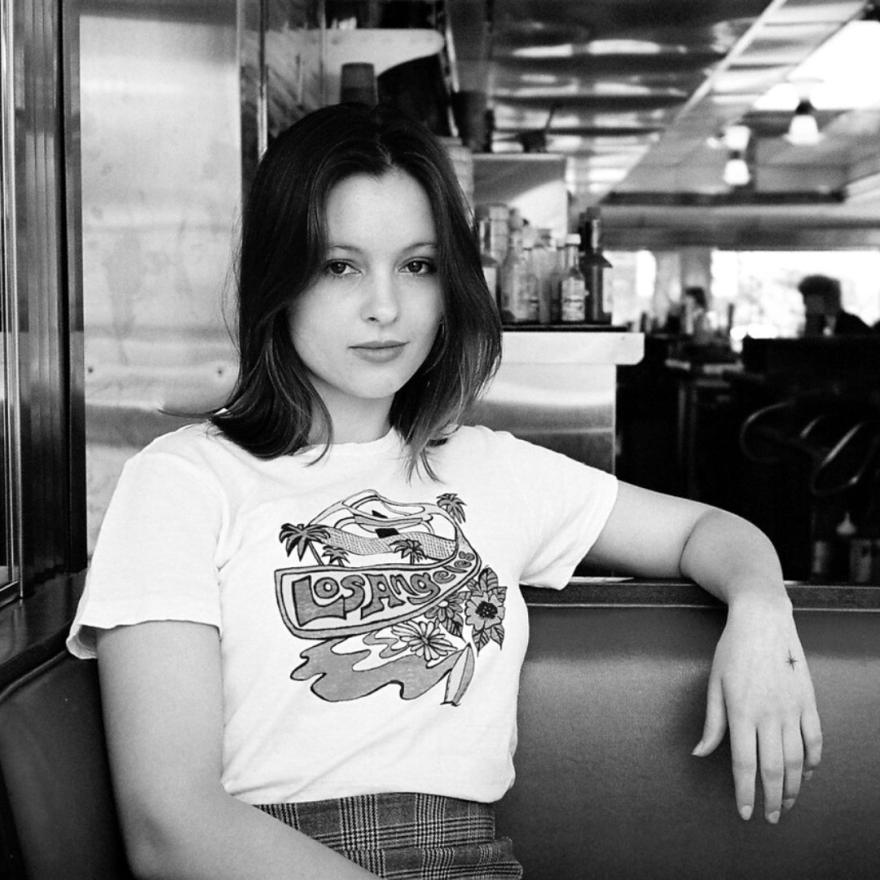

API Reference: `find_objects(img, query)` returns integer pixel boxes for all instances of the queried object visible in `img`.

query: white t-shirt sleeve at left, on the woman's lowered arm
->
[67,448,224,658]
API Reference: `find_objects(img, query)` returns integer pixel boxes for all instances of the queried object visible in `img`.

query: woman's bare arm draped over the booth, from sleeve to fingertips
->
[589,483,822,823]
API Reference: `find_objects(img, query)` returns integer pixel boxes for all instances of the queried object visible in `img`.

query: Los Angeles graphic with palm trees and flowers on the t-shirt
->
[275,490,507,705]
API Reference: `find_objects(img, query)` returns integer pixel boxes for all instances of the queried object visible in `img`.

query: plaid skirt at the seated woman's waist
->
[257,793,522,880]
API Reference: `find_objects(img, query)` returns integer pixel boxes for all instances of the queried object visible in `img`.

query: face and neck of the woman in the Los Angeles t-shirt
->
[290,169,443,442]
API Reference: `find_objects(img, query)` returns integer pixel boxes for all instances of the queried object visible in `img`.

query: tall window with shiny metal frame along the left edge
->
[0,0,85,602]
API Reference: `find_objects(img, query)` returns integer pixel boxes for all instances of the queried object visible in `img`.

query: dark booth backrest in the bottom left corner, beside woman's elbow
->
[0,651,131,880]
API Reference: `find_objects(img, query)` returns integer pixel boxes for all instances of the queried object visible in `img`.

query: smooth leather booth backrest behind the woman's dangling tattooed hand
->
[498,606,880,880]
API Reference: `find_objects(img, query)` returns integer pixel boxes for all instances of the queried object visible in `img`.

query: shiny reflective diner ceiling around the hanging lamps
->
[447,0,880,224]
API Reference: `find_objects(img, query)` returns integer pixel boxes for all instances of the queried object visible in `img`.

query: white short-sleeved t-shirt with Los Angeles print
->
[68,425,617,804]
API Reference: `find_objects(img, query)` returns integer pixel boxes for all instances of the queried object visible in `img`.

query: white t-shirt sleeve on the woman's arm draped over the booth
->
[498,437,618,589]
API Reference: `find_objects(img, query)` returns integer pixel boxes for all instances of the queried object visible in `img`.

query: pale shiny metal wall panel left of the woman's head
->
[81,6,241,547]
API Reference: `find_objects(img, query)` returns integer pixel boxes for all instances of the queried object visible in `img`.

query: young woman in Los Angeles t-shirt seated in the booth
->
[69,99,821,880]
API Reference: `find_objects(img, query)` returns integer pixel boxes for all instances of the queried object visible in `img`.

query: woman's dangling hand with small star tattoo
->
[693,595,822,823]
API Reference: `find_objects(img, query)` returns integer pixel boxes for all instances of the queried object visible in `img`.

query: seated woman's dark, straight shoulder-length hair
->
[210,104,501,475]
